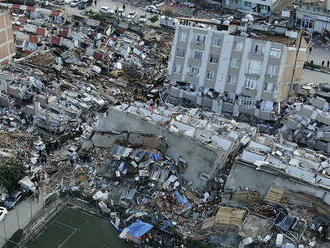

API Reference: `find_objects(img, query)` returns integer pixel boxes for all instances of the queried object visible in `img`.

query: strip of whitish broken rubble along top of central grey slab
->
[112,102,256,153]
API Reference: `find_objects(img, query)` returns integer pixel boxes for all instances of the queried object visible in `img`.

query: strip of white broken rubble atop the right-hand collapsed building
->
[238,135,330,190]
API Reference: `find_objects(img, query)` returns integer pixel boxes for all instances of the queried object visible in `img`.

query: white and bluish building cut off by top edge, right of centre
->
[224,0,278,16]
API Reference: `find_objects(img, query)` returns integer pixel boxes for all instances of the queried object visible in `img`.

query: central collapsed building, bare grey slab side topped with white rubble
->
[96,102,256,188]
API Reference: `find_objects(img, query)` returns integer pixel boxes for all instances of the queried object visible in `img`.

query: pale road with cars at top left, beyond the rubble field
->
[65,0,159,26]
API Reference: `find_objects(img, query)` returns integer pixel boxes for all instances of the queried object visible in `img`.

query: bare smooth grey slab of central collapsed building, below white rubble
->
[97,109,227,188]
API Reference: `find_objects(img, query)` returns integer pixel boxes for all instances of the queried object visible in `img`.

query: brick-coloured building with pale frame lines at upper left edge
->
[0,10,15,66]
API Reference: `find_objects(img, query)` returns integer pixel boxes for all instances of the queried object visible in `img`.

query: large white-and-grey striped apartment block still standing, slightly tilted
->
[168,25,307,120]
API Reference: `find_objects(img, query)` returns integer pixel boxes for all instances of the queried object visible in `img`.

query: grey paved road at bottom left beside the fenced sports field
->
[0,196,44,247]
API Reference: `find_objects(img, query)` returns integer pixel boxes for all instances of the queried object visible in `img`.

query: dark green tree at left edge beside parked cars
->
[0,156,26,192]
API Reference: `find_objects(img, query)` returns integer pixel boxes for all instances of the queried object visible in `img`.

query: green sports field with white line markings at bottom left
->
[27,207,129,248]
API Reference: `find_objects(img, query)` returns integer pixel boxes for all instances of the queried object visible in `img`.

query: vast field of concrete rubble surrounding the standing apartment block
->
[0,0,330,248]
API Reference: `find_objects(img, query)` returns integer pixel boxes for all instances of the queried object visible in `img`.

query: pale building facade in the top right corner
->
[296,0,330,33]
